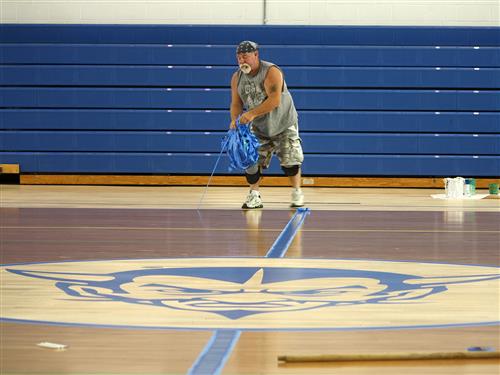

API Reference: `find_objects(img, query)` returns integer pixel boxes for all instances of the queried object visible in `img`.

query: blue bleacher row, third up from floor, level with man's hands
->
[0,109,500,133]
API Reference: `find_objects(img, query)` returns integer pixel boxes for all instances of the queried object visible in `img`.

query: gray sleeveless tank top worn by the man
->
[238,60,298,137]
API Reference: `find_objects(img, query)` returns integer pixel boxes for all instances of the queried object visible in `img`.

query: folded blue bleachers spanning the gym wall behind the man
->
[0,24,500,177]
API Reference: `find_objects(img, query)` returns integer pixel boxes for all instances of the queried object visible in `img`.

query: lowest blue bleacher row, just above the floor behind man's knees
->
[2,152,500,176]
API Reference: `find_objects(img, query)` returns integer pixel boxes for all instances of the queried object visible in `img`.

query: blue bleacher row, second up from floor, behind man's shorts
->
[0,131,500,155]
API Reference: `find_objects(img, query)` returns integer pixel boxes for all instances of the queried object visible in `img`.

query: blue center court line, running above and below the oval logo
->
[188,208,310,375]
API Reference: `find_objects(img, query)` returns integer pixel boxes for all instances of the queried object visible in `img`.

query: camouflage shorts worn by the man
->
[256,127,304,169]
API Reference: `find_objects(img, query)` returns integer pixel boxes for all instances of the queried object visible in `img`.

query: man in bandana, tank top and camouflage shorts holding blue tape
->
[229,40,304,209]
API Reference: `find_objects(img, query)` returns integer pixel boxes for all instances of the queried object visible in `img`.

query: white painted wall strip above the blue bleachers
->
[0,0,500,26]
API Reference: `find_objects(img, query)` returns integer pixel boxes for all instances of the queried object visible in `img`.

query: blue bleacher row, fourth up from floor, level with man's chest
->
[0,87,500,111]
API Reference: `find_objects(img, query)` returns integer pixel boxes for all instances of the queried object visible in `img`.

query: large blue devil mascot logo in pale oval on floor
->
[2,258,500,329]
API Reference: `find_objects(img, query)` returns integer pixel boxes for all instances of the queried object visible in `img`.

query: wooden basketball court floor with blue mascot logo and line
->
[0,185,500,375]
